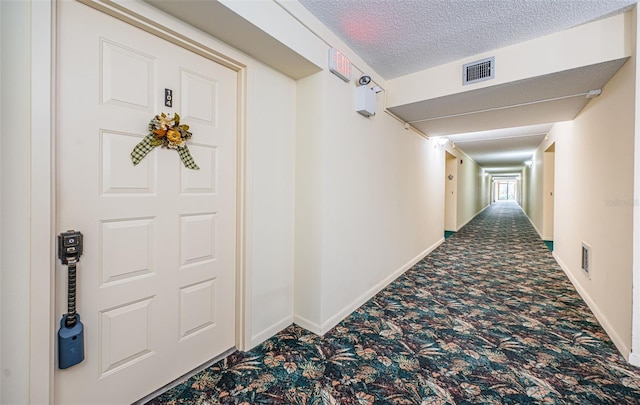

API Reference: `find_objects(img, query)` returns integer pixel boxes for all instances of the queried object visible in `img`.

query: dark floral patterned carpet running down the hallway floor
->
[148,202,640,405]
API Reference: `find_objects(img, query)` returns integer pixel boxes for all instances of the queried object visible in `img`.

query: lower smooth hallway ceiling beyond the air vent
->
[400,58,628,167]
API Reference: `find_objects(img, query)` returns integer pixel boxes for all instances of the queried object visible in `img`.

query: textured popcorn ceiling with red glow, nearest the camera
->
[299,0,637,80]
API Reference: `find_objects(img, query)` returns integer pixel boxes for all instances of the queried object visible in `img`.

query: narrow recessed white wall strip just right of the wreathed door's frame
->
[248,63,296,346]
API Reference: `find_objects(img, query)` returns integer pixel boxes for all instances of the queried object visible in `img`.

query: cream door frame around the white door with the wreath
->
[28,0,251,403]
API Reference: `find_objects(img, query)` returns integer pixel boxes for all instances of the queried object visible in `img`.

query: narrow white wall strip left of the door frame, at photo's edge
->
[0,2,31,404]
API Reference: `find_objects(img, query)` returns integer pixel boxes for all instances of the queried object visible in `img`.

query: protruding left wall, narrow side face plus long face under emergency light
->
[295,67,444,334]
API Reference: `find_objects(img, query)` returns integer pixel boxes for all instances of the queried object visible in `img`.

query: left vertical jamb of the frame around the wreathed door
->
[28,1,56,404]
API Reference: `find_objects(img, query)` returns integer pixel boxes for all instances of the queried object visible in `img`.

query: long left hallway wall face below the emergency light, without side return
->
[319,73,444,332]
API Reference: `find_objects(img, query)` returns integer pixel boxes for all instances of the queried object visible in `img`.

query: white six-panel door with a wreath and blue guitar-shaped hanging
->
[55,1,237,404]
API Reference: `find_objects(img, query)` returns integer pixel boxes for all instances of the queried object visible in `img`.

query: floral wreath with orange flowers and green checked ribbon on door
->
[131,113,200,170]
